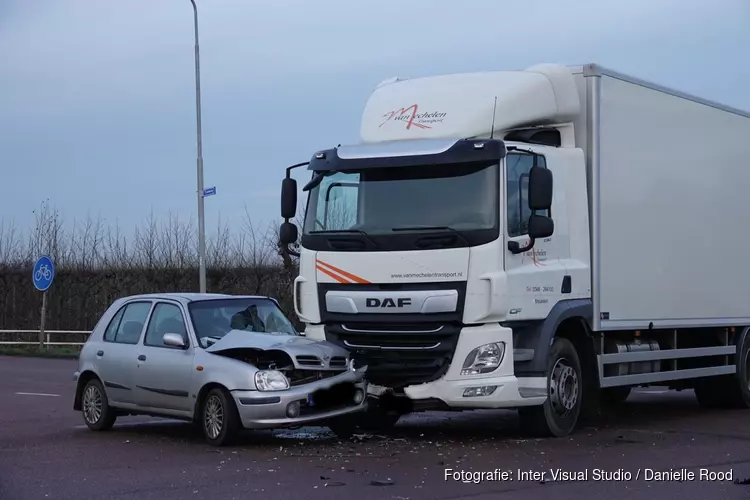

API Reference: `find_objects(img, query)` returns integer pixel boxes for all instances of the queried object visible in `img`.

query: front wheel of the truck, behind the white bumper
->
[518,337,583,437]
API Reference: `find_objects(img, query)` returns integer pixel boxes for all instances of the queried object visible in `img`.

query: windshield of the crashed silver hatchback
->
[188,298,297,348]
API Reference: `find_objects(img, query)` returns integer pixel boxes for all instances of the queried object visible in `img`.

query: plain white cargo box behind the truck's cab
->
[576,65,750,330]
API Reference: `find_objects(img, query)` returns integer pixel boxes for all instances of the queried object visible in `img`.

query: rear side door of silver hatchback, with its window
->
[94,300,152,406]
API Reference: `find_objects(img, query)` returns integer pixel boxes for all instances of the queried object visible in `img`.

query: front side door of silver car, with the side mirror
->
[135,301,195,412]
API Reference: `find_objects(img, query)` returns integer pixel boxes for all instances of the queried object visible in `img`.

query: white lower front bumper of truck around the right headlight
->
[400,324,547,409]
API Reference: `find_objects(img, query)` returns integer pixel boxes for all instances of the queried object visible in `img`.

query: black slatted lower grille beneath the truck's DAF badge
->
[325,322,461,388]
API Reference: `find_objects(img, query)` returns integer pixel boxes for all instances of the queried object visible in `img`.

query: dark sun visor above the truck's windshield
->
[307,139,506,172]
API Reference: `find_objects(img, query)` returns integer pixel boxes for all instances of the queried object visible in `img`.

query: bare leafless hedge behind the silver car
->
[0,201,301,330]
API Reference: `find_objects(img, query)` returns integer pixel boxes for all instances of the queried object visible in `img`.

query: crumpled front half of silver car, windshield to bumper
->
[188,297,367,444]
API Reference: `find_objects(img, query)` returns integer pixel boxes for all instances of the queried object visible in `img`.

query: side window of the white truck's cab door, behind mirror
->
[505,153,549,238]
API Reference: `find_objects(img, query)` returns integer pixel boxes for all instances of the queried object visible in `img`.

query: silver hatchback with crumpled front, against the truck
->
[73,293,367,446]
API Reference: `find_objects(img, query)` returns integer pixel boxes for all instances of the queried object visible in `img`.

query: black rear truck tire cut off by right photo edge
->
[695,332,750,409]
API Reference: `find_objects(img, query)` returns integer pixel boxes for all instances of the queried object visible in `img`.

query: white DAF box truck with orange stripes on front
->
[280,64,750,436]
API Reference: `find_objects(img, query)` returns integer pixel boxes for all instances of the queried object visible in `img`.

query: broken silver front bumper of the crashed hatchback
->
[231,370,367,429]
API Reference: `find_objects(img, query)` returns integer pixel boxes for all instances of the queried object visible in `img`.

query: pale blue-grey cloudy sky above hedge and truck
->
[0,0,750,242]
